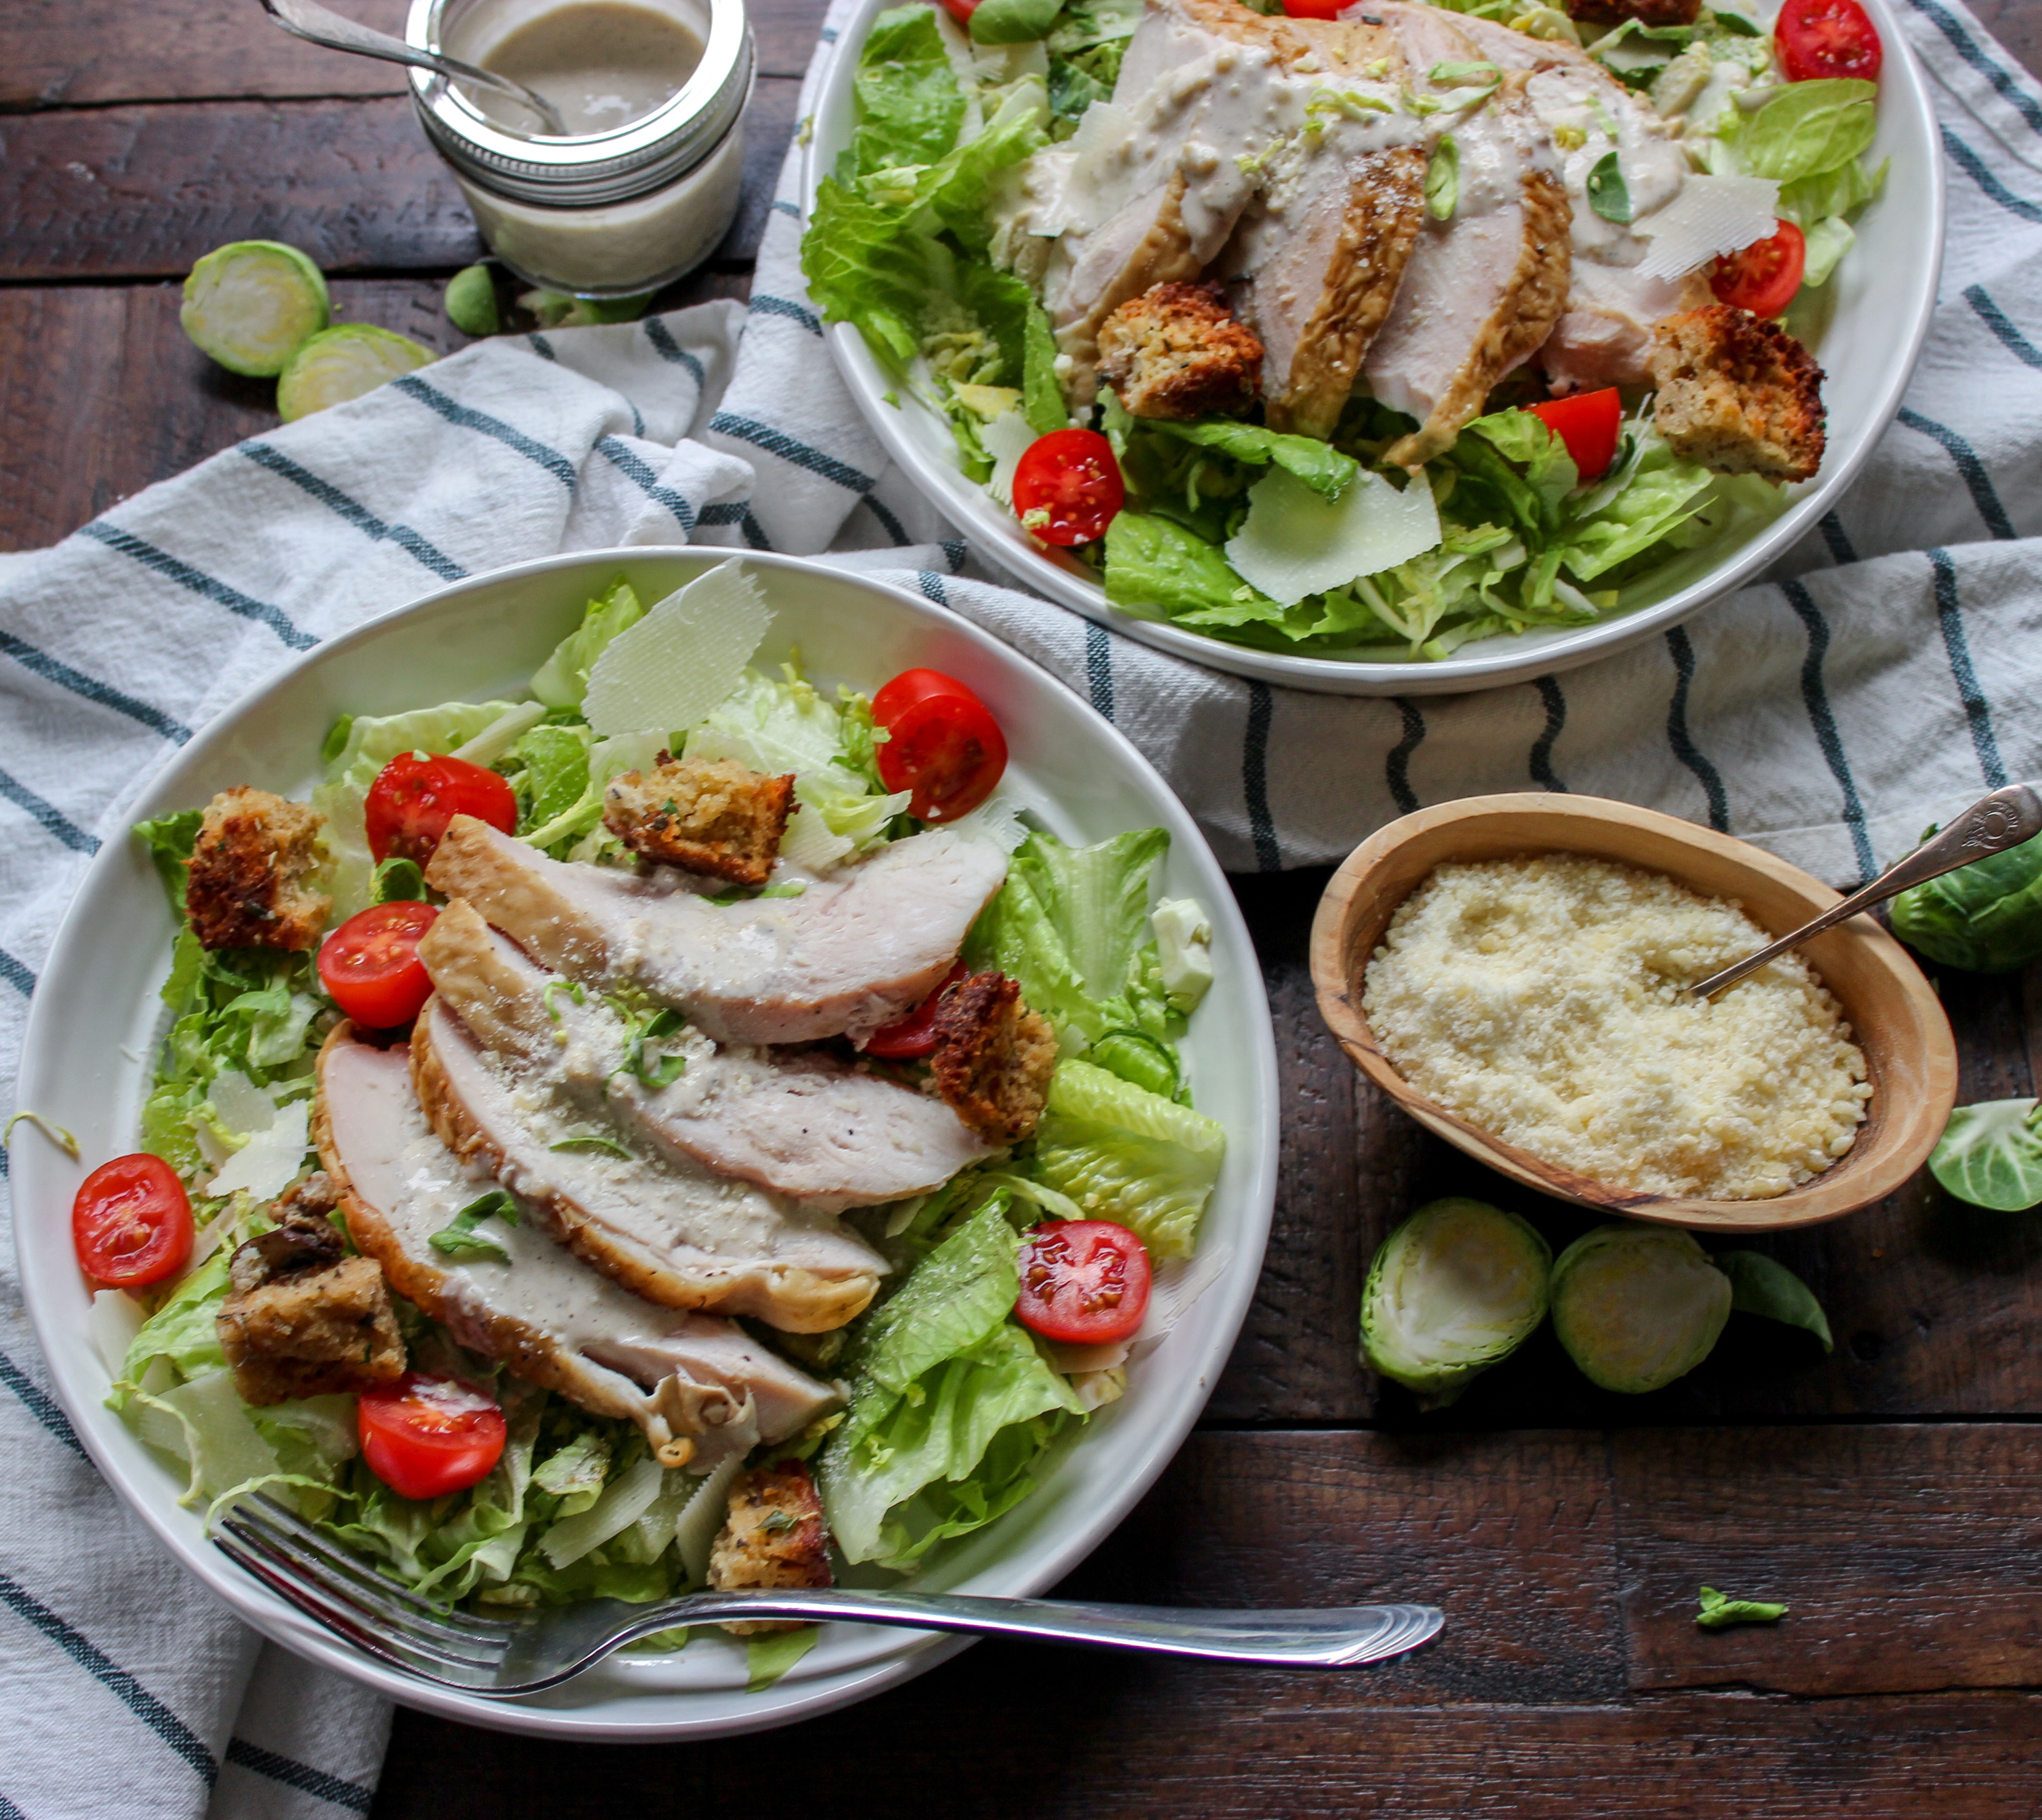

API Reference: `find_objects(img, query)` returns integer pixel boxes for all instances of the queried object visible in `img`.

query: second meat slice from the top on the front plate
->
[419,899,993,1213]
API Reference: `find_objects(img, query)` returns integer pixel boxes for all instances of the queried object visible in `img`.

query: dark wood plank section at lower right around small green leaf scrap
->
[1611,1424,2042,1695]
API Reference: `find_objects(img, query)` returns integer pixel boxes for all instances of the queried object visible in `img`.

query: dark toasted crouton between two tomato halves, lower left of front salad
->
[216,1209,404,1407]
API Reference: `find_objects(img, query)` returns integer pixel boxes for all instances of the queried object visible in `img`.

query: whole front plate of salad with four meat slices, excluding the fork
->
[16,551,1274,1736]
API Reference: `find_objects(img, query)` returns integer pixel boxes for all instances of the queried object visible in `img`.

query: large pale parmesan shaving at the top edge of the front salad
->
[582,562,772,735]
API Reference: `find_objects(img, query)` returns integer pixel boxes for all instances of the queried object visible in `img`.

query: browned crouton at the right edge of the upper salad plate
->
[1652,304,1823,480]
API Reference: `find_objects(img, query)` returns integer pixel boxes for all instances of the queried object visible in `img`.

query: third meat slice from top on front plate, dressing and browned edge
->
[410,997,886,1334]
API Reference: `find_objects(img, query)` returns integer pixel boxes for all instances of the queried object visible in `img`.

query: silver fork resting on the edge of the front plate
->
[212,1497,1444,1699]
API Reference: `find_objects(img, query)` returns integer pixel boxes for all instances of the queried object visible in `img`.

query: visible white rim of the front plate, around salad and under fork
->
[12,549,1276,1740]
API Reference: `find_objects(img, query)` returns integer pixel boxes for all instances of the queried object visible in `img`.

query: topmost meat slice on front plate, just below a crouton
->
[427,815,1007,1044]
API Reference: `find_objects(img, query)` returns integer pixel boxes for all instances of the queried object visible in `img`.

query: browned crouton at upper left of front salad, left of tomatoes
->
[184,784,333,950]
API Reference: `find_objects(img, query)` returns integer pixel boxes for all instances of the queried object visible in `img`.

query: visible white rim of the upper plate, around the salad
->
[802,0,1944,695]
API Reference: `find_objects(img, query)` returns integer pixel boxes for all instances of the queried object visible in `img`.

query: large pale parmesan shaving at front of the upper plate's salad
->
[1227,468,1440,607]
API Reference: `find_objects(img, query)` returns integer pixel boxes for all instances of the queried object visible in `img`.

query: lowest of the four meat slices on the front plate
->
[312,1023,837,1471]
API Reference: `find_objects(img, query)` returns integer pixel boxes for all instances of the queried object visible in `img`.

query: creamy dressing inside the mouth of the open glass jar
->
[470,0,702,133]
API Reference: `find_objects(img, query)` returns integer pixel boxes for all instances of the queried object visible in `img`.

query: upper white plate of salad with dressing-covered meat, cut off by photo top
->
[802,0,1942,693]
